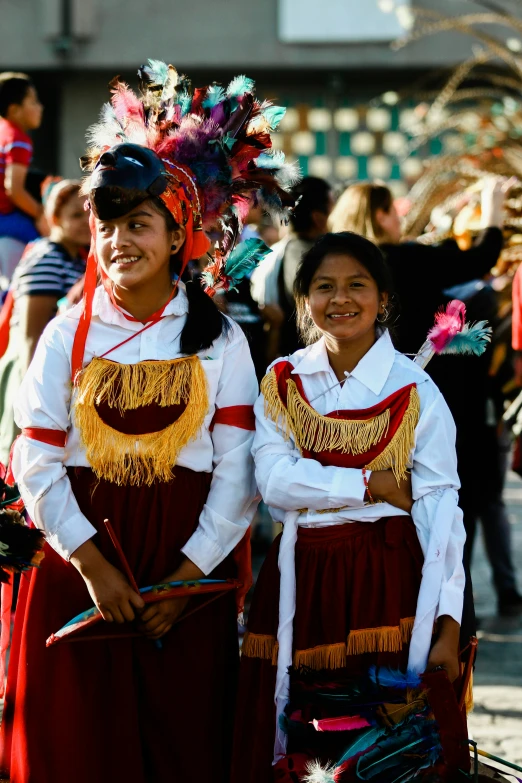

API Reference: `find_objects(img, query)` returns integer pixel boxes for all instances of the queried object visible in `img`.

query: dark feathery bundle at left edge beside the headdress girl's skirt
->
[0,464,44,582]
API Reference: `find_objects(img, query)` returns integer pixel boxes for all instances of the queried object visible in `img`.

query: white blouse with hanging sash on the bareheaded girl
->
[252,331,466,760]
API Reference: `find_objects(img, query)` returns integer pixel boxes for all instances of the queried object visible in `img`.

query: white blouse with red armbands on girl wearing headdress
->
[13,284,258,574]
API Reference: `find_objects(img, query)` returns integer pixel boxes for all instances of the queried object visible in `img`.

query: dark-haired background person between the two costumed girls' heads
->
[252,177,334,362]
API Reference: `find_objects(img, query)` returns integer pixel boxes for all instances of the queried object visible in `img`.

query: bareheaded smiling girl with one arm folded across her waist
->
[233,233,465,783]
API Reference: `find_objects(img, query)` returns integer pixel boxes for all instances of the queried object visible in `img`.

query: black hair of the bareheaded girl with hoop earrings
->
[294,231,394,344]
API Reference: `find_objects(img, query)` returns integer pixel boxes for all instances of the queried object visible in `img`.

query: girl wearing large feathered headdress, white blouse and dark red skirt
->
[0,61,297,783]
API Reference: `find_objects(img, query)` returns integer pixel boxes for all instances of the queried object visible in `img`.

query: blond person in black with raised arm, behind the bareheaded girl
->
[329,177,522,615]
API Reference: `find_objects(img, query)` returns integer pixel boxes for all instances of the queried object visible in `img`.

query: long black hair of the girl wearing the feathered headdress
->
[152,198,230,354]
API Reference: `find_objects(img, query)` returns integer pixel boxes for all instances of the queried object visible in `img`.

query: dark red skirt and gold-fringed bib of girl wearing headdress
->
[0,356,238,783]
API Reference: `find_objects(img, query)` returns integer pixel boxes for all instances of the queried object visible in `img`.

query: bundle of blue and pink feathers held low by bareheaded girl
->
[275,667,469,783]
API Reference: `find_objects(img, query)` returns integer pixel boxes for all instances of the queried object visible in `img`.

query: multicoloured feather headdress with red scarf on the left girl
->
[73,60,300,380]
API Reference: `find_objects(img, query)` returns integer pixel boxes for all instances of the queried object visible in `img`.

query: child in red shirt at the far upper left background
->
[0,72,46,243]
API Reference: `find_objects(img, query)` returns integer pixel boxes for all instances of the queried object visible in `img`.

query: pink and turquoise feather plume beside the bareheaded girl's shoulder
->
[414,299,492,367]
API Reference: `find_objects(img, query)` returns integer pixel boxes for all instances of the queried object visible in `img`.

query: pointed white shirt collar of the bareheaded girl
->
[293,329,395,394]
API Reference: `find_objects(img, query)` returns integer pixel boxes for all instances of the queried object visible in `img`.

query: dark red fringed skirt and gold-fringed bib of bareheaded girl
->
[232,362,468,783]
